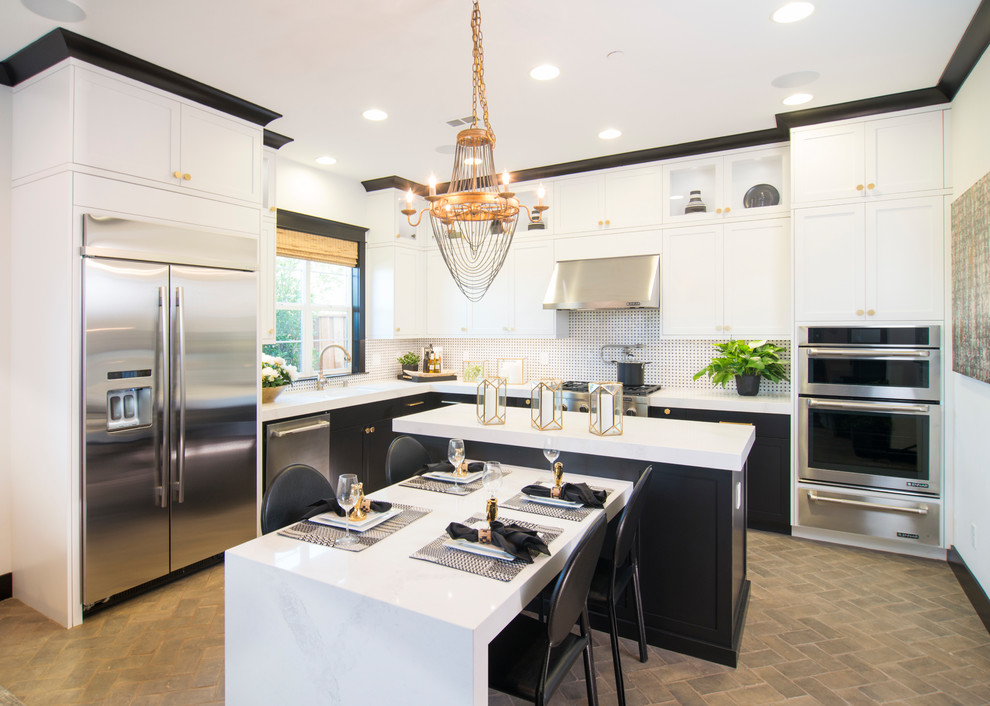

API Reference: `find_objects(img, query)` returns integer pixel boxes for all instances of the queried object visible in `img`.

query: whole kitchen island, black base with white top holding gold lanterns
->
[393,405,756,666]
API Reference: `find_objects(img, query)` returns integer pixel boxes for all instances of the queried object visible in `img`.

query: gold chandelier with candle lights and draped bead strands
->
[401,0,549,302]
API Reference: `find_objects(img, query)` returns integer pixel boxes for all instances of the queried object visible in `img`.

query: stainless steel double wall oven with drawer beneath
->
[797,326,942,545]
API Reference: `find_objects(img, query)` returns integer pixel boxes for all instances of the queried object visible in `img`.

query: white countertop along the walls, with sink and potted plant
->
[261,380,791,422]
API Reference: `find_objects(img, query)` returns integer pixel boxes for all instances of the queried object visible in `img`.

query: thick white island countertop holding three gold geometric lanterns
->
[392,398,756,471]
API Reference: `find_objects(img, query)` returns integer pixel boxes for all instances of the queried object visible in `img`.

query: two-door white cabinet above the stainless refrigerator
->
[73,67,262,203]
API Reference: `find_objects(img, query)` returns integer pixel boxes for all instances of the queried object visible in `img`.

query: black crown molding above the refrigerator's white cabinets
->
[0,27,282,126]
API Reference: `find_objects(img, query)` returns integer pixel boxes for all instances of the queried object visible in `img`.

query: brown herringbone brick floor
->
[0,532,990,706]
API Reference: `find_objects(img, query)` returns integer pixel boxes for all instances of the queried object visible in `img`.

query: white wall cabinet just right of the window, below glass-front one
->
[366,245,426,339]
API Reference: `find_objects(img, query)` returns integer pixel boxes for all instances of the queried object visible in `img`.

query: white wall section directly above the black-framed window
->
[276,156,367,226]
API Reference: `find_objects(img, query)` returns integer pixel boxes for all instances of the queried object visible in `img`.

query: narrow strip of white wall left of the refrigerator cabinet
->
[0,86,12,575]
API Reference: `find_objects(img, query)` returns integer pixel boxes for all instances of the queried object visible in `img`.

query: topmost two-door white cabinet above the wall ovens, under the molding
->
[791,110,945,206]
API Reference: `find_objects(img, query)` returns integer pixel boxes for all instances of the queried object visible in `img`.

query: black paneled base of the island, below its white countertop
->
[416,436,749,667]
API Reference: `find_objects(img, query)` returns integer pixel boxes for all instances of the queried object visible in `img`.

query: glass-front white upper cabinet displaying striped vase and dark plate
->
[663,147,790,223]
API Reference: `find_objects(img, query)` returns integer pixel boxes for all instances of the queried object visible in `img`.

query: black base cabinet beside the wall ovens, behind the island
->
[650,407,791,534]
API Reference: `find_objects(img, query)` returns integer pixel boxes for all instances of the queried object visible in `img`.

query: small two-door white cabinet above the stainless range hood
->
[550,167,661,235]
